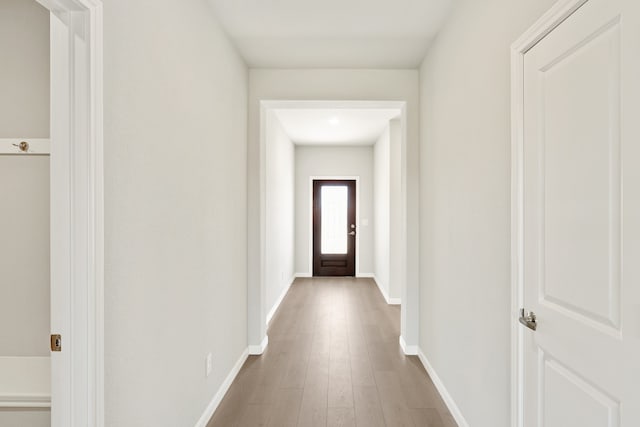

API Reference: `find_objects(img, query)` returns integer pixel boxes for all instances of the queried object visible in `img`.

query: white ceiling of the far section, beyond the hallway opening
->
[274,109,401,145]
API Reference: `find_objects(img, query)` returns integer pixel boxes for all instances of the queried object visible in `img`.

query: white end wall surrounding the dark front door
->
[296,145,373,275]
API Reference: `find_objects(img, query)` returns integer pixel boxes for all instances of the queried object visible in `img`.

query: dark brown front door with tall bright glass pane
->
[313,180,356,276]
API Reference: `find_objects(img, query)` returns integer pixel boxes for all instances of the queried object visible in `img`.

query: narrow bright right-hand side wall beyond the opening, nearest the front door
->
[373,126,391,300]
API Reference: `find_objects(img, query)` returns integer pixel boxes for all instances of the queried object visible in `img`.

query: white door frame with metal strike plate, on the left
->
[37,0,104,427]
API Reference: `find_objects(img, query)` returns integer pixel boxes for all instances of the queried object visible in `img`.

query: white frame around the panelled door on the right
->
[511,0,588,427]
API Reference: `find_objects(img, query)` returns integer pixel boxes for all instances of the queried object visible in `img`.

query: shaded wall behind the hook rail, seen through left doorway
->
[0,0,51,427]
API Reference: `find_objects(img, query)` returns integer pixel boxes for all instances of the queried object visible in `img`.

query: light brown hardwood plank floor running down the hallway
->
[208,278,456,427]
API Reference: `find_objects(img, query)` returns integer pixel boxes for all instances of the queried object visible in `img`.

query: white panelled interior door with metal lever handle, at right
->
[523,0,640,427]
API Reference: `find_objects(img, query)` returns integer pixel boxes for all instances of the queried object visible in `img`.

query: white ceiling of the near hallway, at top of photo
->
[209,0,454,68]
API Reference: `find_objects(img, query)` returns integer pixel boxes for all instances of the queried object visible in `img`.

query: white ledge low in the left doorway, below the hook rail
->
[0,356,51,408]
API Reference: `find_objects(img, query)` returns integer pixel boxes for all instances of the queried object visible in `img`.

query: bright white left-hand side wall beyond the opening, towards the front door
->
[265,112,295,320]
